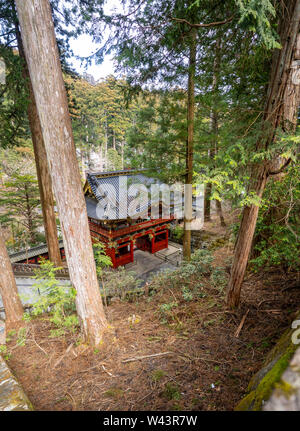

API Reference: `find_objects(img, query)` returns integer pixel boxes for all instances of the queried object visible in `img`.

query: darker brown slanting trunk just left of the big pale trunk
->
[15,23,62,266]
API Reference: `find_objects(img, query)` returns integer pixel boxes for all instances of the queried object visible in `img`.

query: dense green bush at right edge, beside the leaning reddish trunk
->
[250,164,300,272]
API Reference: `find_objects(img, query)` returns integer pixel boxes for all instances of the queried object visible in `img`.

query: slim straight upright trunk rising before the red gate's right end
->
[183,29,197,260]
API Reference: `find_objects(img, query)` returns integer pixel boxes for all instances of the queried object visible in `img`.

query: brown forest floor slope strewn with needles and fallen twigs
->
[4,213,300,411]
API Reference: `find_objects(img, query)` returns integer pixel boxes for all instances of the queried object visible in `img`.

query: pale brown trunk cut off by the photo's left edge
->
[0,226,23,329]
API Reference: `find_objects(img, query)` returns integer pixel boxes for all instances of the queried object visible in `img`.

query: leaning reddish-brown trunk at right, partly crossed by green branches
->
[227,0,300,308]
